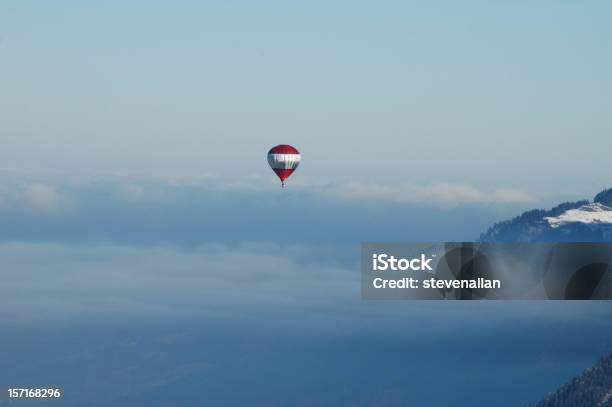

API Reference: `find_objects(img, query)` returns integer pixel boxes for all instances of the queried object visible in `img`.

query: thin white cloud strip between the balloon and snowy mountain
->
[325,182,537,206]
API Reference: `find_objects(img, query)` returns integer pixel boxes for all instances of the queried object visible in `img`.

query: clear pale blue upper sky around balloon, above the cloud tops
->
[0,1,612,198]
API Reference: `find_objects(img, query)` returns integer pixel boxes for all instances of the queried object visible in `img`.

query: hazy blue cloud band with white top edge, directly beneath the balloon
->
[0,175,532,247]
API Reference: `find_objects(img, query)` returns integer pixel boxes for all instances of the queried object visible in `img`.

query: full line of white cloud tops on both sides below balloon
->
[0,172,538,210]
